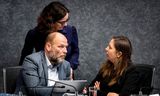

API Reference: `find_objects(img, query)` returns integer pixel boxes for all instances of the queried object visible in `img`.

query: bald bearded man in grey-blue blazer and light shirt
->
[16,32,71,96]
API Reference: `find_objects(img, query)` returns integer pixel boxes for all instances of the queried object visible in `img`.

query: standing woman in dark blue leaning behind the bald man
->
[19,1,79,77]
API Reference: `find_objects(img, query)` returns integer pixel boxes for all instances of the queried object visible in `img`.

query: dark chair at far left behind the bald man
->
[3,66,22,94]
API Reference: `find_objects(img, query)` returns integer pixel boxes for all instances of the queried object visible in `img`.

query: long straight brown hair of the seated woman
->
[100,36,132,86]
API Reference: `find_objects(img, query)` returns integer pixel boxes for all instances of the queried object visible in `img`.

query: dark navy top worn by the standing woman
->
[19,25,79,70]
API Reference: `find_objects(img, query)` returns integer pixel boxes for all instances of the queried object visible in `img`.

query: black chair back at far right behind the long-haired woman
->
[136,64,155,95]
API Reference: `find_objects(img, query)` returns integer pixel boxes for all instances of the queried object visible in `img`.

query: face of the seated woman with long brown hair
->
[105,39,119,64]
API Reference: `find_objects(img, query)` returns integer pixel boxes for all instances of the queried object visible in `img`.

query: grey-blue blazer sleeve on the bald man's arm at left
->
[22,55,53,96]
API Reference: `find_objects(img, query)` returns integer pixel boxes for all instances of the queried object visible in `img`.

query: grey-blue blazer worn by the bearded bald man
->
[16,51,71,96]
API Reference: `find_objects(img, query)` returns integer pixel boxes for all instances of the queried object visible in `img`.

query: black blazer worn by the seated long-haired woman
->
[90,65,139,96]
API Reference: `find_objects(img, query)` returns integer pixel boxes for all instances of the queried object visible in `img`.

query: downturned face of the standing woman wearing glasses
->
[52,13,69,31]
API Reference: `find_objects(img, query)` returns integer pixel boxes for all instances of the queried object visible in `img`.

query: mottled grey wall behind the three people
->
[0,0,160,93]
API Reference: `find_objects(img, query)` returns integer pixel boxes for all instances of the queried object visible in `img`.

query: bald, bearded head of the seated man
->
[44,32,68,63]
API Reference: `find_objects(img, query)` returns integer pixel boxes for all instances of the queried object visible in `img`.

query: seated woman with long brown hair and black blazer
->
[90,36,138,96]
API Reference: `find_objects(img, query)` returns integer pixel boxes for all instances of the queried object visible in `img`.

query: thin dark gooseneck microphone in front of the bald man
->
[25,73,78,96]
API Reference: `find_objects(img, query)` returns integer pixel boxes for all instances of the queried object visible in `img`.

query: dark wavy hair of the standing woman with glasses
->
[37,1,69,32]
